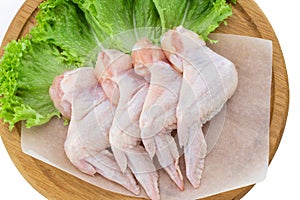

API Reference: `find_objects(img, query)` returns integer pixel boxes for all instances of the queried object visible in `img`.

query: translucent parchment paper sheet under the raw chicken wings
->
[21,34,272,200]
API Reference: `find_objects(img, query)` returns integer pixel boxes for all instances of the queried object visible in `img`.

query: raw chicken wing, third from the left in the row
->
[132,39,184,190]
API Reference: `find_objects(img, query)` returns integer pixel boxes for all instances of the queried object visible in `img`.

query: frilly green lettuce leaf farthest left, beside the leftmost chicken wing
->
[0,38,75,129]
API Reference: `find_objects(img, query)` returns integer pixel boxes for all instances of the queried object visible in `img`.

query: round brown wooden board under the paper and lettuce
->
[0,0,289,200]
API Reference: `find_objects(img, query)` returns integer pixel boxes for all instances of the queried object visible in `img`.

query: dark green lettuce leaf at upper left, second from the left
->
[30,0,98,66]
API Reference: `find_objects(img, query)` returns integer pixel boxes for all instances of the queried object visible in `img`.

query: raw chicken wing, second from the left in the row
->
[95,50,160,199]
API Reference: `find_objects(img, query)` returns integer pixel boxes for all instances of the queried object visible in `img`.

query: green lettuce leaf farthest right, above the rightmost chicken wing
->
[153,0,232,40]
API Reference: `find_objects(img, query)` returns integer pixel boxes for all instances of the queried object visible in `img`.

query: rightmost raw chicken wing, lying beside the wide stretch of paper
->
[161,27,238,188]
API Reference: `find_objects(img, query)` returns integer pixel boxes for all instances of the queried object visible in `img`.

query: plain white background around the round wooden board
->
[0,0,300,200]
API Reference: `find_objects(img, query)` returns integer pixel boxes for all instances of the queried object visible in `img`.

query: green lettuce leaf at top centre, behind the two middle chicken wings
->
[73,0,161,53]
